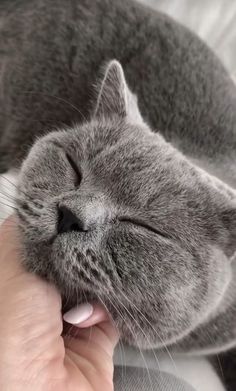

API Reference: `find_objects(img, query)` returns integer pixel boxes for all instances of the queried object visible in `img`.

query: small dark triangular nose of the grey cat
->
[57,206,87,234]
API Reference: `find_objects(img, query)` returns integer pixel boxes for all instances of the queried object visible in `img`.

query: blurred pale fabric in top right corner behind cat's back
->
[138,0,236,80]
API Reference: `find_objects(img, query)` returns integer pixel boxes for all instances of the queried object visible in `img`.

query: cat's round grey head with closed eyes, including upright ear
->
[15,61,236,348]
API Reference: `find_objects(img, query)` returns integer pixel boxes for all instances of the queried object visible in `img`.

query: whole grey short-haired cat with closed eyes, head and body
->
[0,0,236,374]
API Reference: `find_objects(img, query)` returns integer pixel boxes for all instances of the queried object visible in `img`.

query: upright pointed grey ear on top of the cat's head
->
[94,60,143,123]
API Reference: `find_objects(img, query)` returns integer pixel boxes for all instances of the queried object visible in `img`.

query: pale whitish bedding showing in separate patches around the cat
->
[0,0,236,391]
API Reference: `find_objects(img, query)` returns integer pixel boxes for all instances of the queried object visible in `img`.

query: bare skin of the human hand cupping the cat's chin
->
[0,217,118,391]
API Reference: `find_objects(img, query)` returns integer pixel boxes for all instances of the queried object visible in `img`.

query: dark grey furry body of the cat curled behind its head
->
[0,0,236,186]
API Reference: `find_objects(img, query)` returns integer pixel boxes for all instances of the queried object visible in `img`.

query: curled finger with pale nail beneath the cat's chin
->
[64,310,118,390]
